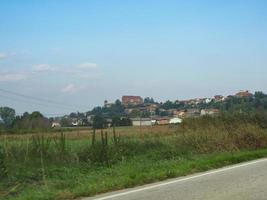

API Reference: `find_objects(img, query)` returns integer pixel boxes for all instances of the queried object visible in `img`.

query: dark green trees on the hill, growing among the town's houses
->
[87,92,267,118]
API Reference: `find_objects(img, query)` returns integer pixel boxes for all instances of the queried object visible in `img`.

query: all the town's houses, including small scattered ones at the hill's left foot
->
[52,91,253,127]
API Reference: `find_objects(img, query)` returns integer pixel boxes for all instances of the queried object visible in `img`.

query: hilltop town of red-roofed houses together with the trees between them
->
[52,90,264,127]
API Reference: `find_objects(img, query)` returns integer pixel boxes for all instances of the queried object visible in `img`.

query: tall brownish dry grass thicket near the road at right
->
[180,115,267,153]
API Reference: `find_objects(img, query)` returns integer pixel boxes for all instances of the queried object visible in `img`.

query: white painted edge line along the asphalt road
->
[90,158,267,200]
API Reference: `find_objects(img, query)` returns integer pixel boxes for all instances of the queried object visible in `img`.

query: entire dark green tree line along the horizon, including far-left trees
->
[0,92,267,133]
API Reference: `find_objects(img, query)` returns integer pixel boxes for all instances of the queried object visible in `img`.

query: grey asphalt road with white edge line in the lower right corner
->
[83,159,267,200]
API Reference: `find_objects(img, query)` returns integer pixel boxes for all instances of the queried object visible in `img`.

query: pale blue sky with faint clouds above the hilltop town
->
[0,0,267,115]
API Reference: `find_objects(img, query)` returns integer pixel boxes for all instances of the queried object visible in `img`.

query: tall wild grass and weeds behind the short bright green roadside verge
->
[0,115,267,199]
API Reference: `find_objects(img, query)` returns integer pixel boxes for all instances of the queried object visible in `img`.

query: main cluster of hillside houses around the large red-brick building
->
[117,90,253,126]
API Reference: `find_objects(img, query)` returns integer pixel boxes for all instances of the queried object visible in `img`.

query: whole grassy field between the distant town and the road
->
[0,117,267,200]
